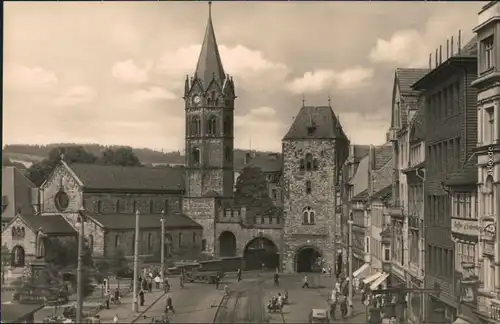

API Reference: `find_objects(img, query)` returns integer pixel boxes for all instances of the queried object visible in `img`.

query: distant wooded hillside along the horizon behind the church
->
[2,143,280,167]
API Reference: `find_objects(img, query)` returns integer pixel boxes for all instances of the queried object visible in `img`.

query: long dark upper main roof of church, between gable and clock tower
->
[69,164,184,191]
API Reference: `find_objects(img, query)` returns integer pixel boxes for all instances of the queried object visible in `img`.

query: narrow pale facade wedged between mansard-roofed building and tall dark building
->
[402,105,425,323]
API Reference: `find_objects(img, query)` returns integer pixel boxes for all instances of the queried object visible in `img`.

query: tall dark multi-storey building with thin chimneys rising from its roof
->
[413,37,477,321]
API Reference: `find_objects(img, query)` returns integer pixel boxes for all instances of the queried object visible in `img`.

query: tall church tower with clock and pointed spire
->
[184,2,236,198]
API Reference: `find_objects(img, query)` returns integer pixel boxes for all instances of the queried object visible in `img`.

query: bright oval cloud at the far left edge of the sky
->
[3,65,58,90]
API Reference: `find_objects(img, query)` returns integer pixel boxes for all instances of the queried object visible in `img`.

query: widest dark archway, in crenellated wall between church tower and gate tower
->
[243,237,279,271]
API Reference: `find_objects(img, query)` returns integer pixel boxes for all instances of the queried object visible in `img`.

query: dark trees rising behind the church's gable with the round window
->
[26,145,97,186]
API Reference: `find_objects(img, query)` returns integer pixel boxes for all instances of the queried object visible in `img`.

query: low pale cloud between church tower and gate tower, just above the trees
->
[234,107,287,151]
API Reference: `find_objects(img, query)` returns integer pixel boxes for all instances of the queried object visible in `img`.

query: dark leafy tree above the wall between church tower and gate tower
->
[234,166,274,215]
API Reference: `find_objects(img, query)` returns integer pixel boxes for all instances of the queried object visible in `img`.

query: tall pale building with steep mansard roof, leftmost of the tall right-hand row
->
[388,68,428,294]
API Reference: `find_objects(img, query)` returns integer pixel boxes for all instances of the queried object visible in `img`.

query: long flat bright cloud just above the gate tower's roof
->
[287,66,373,93]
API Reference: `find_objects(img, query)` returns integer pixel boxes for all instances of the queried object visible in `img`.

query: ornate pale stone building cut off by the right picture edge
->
[470,1,500,323]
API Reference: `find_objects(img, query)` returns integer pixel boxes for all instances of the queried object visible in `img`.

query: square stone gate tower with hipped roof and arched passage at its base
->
[282,105,349,272]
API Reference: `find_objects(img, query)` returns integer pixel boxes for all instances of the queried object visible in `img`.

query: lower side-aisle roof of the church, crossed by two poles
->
[90,214,201,230]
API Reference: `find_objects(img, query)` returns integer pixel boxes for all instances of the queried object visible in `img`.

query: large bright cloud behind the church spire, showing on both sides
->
[156,44,290,91]
